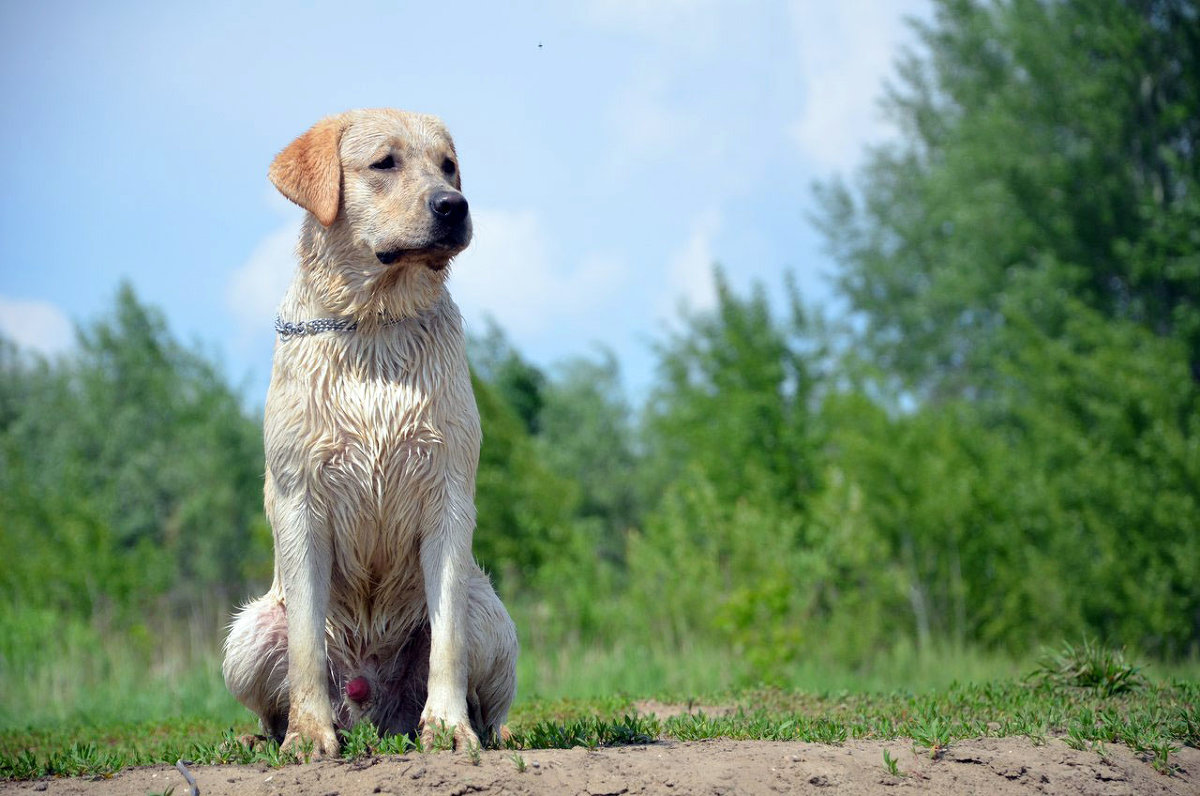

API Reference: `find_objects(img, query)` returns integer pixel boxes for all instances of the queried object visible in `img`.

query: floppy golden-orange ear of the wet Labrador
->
[268,116,344,227]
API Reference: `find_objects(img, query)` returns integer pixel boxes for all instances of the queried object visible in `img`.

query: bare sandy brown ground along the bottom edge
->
[0,738,1200,796]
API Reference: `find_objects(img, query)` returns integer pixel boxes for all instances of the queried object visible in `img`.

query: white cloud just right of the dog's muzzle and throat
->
[450,208,628,342]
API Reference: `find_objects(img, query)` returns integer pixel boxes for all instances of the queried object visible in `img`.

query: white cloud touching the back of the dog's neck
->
[226,216,301,336]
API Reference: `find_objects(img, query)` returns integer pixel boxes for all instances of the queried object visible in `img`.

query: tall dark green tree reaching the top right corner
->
[818,0,1200,396]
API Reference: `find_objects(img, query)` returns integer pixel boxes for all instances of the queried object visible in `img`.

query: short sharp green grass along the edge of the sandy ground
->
[0,645,1200,779]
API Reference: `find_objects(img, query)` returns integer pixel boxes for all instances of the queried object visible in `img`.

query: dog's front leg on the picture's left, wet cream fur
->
[275,492,340,758]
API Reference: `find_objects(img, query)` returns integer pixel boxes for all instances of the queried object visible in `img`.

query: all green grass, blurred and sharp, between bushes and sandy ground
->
[0,638,1200,779]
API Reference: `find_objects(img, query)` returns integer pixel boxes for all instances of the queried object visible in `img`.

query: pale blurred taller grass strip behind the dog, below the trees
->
[0,617,1030,730]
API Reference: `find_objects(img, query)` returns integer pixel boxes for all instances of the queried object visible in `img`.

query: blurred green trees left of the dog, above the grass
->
[0,285,270,618]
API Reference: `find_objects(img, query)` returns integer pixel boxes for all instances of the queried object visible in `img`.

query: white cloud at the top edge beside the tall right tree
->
[791,0,928,170]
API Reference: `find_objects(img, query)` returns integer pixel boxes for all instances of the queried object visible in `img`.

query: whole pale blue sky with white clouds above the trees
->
[0,0,930,406]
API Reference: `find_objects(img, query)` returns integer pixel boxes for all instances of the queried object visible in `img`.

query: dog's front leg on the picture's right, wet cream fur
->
[421,495,480,749]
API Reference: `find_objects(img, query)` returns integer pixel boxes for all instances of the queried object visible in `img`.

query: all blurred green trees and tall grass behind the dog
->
[0,0,1200,726]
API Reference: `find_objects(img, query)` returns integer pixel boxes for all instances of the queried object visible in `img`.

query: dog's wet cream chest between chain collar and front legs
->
[265,340,480,535]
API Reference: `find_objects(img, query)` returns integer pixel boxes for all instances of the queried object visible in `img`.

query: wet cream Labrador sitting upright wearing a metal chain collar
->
[222,109,517,758]
